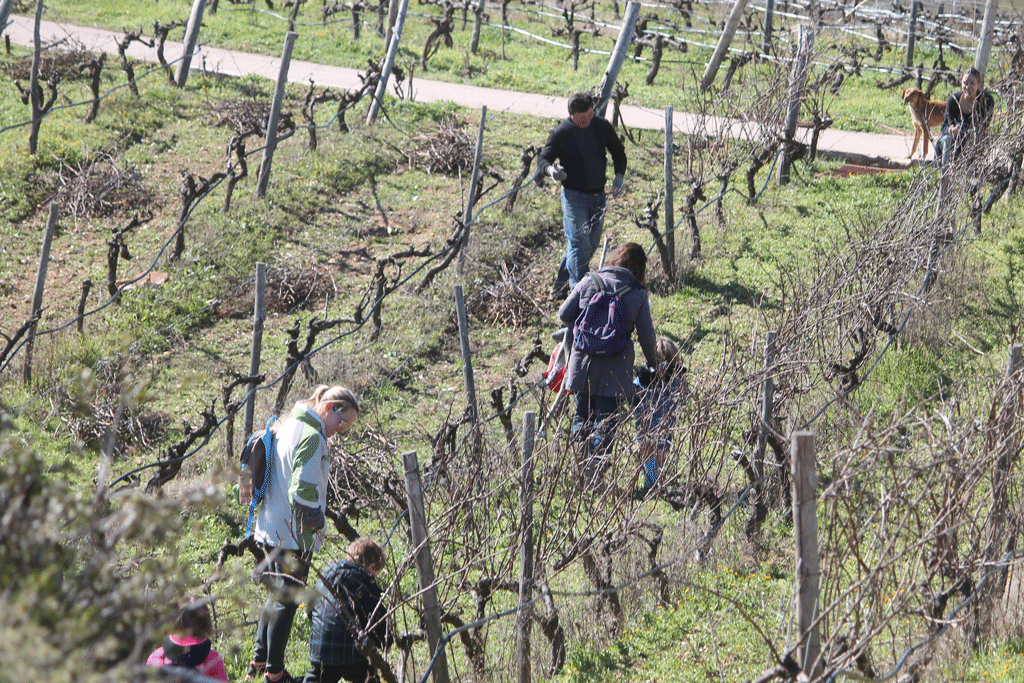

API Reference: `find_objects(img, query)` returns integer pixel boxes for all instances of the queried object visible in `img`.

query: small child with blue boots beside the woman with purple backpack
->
[634,337,686,495]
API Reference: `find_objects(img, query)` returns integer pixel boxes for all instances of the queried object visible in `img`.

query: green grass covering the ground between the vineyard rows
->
[0,2,1024,682]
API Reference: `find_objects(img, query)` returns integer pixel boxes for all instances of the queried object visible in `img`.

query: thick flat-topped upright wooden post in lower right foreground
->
[791,431,821,680]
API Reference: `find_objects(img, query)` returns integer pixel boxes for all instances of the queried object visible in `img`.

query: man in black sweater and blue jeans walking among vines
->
[538,92,627,299]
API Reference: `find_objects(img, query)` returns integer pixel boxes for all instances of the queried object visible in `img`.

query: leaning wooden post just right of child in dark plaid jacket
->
[401,451,449,683]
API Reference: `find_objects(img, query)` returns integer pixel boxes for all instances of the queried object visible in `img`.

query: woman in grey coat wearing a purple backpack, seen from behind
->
[558,242,657,486]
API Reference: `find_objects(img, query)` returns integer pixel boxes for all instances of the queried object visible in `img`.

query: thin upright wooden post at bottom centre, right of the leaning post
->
[515,411,537,683]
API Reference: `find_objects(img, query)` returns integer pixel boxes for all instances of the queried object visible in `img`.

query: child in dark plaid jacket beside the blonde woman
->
[303,538,391,683]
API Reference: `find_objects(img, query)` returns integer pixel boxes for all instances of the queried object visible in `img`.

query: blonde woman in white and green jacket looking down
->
[246,385,359,683]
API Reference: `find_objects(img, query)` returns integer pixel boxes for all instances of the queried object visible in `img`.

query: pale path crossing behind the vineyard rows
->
[7,15,913,168]
